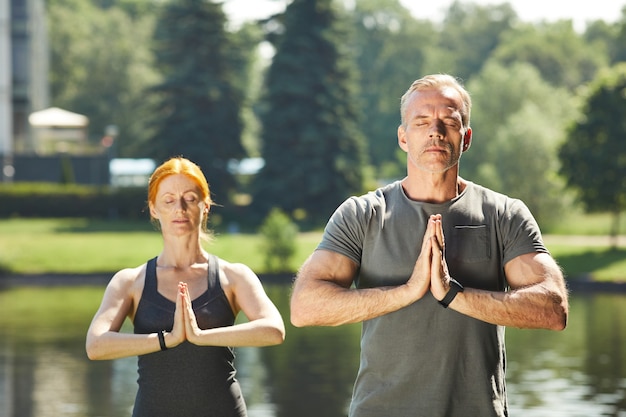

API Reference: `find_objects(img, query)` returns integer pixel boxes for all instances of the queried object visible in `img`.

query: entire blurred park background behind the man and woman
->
[0,0,626,417]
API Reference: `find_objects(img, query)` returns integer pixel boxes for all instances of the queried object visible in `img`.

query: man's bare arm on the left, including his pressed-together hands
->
[291,214,452,326]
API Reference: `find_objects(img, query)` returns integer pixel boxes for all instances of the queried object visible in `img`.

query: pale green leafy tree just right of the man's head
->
[461,62,575,226]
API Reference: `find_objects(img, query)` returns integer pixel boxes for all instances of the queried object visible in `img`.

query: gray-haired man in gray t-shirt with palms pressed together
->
[291,74,568,417]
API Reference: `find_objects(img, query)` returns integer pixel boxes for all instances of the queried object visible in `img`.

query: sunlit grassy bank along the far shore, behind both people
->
[0,217,626,281]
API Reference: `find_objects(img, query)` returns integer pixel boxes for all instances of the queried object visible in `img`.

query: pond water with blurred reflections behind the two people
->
[0,285,626,417]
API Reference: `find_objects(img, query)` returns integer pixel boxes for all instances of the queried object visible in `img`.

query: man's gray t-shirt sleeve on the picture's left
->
[317,197,367,265]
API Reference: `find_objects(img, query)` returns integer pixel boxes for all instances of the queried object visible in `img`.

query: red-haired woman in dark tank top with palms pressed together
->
[86,157,285,417]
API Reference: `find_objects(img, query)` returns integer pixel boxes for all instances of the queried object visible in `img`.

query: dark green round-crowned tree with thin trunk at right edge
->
[559,63,626,245]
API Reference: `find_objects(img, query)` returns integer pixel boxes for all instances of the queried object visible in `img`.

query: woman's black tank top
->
[133,255,247,417]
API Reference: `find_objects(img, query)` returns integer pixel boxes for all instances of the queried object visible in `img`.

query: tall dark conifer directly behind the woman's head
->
[147,0,246,203]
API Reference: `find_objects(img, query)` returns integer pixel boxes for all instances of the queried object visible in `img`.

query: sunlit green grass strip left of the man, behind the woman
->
[0,219,321,274]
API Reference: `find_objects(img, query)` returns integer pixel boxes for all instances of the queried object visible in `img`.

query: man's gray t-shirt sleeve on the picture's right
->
[500,199,549,264]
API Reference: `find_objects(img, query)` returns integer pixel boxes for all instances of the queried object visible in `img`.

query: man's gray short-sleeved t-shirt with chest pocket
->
[318,182,547,417]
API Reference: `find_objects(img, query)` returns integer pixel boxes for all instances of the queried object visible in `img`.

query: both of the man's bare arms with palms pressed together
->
[291,214,567,329]
